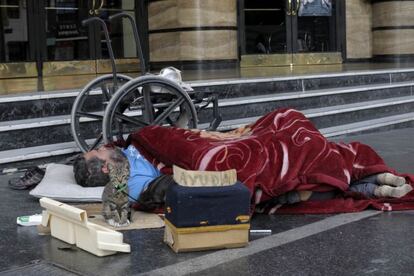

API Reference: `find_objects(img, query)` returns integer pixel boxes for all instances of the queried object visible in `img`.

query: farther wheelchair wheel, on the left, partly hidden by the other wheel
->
[71,74,132,152]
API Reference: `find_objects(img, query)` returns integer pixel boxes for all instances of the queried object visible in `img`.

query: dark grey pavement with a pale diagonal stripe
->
[0,128,414,276]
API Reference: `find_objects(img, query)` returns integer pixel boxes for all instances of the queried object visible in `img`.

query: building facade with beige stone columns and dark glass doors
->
[0,0,414,79]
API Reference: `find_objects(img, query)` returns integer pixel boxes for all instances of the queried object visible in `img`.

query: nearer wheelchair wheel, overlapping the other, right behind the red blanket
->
[102,76,197,143]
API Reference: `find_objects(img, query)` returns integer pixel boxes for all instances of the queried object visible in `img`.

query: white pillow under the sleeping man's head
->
[29,164,104,202]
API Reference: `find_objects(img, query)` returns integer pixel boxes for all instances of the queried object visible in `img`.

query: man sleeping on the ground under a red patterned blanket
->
[74,109,413,209]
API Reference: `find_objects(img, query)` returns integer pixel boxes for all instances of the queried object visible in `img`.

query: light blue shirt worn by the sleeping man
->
[122,145,161,201]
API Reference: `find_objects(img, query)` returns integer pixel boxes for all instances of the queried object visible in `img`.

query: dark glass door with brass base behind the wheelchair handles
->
[41,0,143,76]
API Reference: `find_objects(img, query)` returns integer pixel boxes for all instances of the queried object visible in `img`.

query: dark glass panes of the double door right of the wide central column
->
[244,0,337,54]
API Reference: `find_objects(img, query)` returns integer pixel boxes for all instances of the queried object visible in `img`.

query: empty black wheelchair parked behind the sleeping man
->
[71,13,222,152]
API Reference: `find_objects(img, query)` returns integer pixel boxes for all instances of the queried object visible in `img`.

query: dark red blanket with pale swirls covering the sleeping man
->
[130,109,414,212]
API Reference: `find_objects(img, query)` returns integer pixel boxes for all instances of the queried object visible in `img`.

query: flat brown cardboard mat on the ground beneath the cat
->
[73,203,165,231]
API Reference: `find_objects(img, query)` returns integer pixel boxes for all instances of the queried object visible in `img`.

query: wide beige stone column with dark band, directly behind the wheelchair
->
[148,0,238,67]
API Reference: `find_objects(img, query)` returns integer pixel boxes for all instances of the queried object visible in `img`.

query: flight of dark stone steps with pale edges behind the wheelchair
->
[0,69,414,168]
